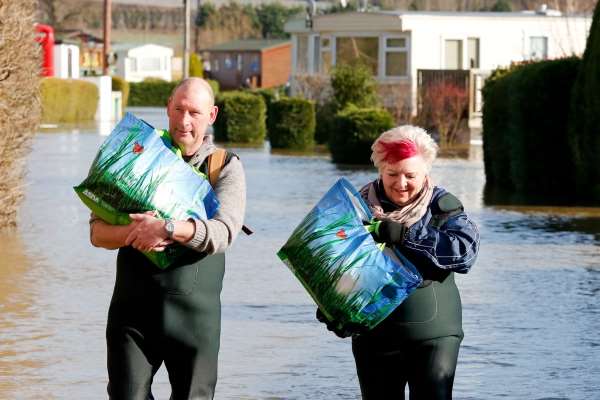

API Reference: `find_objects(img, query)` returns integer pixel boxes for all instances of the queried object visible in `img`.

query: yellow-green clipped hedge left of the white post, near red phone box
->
[40,78,98,123]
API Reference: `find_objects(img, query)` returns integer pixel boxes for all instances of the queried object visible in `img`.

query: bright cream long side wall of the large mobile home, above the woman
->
[403,16,591,111]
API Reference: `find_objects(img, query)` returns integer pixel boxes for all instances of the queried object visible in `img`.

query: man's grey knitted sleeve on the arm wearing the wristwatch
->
[185,157,246,254]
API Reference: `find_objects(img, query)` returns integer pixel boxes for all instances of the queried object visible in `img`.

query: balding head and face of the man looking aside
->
[167,84,218,156]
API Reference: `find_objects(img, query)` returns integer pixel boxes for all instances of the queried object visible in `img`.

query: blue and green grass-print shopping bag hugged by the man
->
[74,113,219,268]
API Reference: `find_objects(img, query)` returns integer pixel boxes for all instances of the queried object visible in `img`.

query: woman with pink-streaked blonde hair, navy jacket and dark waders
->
[318,125,479,400]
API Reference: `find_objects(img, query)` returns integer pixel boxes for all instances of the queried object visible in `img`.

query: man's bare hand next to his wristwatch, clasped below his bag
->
[125,212,173,251]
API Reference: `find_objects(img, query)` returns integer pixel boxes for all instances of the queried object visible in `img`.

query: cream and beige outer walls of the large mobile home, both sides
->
[289,12,591,111]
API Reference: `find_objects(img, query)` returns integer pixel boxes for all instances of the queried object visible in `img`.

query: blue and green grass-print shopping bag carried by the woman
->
[277,178,421,329]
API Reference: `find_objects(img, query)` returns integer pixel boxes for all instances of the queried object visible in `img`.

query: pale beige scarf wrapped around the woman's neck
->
[361,176,433,228]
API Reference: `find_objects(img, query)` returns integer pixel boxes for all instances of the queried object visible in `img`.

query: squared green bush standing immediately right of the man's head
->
[215,91,267,144]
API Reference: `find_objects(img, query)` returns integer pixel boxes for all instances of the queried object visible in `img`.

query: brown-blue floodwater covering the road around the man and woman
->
[0,109,600,400]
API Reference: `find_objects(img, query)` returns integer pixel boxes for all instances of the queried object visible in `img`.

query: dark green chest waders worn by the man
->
[106,247,225,399]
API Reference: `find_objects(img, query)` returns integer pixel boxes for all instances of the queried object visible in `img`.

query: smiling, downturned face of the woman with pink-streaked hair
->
[379,155,427,206]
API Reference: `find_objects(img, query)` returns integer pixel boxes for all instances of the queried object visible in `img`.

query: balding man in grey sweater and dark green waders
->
[90,78,246,400]
